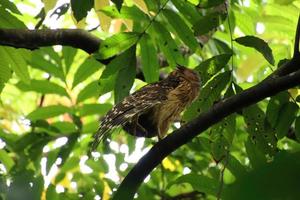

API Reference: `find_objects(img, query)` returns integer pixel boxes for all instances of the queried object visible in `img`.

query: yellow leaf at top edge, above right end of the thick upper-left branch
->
[94,0,112,32]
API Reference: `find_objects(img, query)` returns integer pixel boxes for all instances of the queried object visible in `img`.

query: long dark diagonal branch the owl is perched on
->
[113,54,300,200]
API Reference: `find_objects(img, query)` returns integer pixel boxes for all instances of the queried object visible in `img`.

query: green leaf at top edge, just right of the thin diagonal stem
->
[172,0,201,24]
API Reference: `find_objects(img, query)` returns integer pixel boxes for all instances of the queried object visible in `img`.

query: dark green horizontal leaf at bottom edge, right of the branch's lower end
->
[168,173,218,195]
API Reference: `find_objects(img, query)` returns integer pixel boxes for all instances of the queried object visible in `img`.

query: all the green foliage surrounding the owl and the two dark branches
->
[0,0,300,200]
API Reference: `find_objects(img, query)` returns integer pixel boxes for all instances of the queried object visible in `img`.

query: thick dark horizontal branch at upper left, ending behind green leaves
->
[0,29,101,53]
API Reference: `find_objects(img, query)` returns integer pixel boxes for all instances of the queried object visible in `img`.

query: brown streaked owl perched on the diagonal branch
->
[92,66,201,150]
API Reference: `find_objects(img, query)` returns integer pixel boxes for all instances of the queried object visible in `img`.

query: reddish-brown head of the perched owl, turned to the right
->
[171,66,201,85]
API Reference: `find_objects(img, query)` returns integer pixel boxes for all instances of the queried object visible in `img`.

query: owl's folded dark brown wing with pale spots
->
[92,82,173,150]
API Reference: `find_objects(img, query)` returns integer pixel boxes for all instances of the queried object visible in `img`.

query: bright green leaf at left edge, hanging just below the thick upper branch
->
[0,47,30,83]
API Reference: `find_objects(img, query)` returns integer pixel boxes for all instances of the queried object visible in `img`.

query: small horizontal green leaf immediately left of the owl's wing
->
[78,103,112,117]
